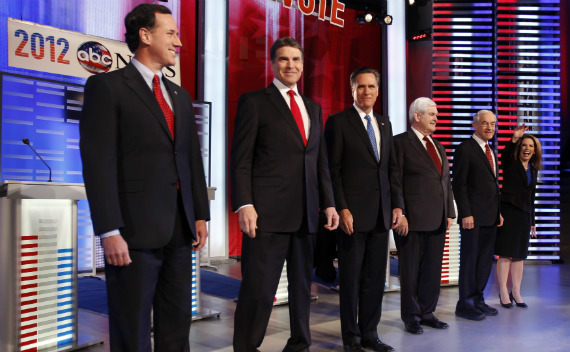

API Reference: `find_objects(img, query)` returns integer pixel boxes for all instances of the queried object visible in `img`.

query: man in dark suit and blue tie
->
[325,67,404,351]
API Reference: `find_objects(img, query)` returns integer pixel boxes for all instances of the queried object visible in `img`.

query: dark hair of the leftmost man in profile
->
[125,4,172,53]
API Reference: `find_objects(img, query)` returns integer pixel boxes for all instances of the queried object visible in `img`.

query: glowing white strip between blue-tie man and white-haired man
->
[386,0,408,135]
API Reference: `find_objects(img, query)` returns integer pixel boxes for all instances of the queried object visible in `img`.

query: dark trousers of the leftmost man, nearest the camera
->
[105,197,192,352]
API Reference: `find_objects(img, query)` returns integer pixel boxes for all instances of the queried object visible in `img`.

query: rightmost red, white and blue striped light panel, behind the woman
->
[496,0,561,260]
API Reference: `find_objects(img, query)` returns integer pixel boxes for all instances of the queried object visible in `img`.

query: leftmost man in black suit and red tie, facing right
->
[79,4,210,352]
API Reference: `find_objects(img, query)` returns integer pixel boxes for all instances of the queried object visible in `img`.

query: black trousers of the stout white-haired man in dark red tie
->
[395,230,445,323]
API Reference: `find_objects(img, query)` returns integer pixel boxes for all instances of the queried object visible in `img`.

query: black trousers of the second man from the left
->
[233,230,315,352]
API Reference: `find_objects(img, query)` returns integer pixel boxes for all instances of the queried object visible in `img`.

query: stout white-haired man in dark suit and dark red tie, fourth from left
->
[394,98,455,334]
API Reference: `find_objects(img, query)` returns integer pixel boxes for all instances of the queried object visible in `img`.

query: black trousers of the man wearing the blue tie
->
[338,225,388,345]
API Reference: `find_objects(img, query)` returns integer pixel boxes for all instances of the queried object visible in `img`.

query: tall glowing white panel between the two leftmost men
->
[204,0,228,258]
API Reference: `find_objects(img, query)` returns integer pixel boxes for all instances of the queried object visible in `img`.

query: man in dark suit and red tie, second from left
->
[230,38,338,352]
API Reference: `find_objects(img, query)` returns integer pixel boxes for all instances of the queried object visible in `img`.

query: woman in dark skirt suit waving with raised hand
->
[495,123,542,308]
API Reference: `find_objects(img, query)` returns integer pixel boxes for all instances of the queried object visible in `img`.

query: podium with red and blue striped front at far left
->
[0,181,102,352]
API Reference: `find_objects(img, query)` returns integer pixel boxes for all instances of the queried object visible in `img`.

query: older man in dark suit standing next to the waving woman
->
[452,110,502,320]
